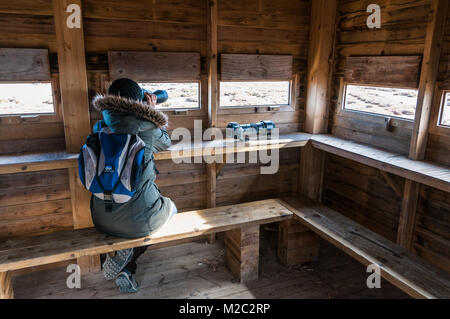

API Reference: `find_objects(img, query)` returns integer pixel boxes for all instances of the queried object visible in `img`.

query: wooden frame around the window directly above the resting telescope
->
[217,74,298,115]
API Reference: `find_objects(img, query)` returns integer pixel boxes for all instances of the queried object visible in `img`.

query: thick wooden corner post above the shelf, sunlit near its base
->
[305,0,337,134]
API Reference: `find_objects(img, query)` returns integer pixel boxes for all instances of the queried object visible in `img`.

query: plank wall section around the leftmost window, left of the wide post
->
[0,1,69,239]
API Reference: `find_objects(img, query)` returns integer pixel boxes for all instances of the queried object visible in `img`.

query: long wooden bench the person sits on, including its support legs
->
[0,199,292,298]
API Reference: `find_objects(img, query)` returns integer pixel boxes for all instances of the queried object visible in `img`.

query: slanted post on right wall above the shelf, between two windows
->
[409,0,448,160]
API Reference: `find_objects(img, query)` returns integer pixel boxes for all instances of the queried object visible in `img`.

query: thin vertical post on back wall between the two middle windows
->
[206,0,219,243]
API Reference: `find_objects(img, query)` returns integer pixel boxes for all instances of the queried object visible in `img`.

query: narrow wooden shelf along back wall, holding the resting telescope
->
[0,133,311,175]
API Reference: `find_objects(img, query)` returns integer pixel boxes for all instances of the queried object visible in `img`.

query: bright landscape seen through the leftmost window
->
[0,83,55,116]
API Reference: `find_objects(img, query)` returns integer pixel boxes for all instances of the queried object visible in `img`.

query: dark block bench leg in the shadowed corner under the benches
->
[278,219,319,266]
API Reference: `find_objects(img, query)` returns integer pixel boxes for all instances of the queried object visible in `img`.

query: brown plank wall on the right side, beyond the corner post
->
[323,0,450,271]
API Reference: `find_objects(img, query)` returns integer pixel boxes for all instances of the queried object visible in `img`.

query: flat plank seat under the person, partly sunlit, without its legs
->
[0,199,292,272]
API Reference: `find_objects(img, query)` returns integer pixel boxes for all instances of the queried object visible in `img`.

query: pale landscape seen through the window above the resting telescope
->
[220,81,290,107]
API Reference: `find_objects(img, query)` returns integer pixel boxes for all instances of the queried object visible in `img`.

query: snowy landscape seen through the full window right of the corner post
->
[344,84,418,120]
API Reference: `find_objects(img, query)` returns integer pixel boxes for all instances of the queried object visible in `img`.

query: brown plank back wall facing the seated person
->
[0,0,310,238]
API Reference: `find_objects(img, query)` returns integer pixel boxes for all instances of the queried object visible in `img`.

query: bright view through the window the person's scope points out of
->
[139,82,200,109]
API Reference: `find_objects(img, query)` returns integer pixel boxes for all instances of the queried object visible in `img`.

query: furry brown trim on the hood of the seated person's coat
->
[92,94,169,128]
